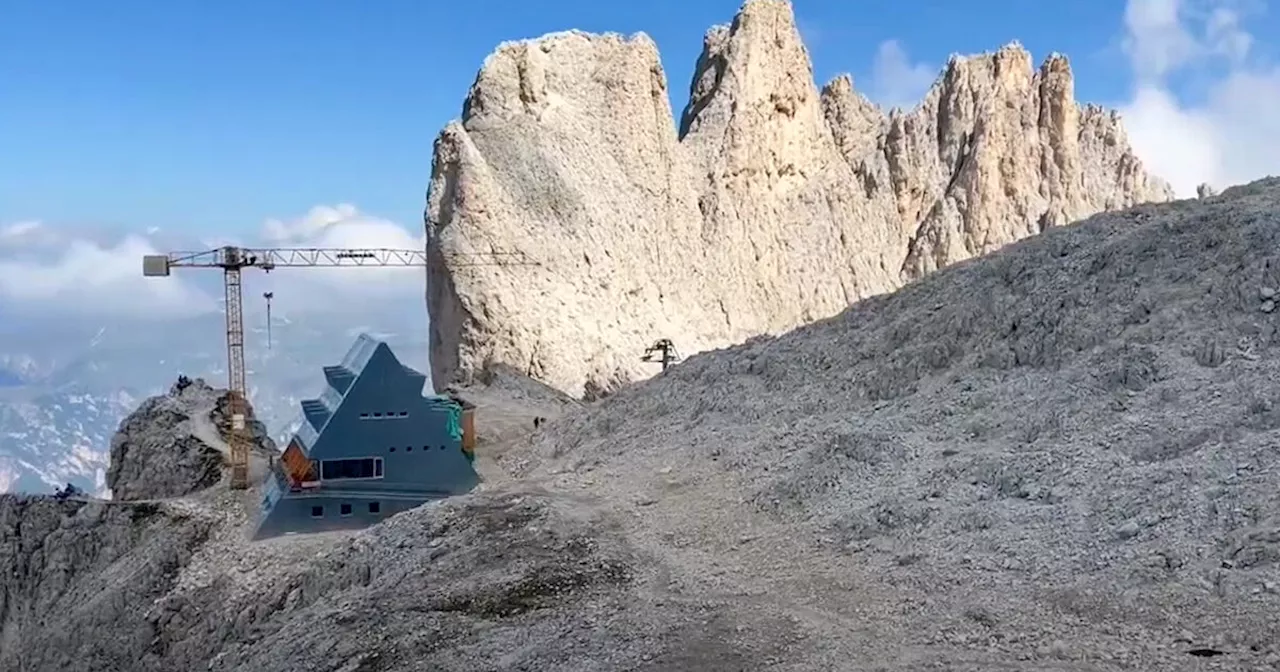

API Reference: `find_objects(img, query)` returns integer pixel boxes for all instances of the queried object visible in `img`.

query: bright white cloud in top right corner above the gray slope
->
[1121,0,1280,196]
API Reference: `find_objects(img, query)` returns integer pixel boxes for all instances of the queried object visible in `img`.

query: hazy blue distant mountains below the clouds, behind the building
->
[0,301,429,492]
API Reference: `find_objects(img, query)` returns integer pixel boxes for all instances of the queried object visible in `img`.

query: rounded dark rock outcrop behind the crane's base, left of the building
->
[106,378,275,500]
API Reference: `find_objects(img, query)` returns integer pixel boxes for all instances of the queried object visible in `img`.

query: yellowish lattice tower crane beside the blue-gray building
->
[142,246,538,490]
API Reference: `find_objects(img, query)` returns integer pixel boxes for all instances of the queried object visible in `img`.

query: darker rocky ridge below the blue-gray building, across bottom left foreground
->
[0,488,794,672]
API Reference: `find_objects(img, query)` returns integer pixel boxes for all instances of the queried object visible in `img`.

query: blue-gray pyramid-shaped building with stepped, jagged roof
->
[253,334,480,539]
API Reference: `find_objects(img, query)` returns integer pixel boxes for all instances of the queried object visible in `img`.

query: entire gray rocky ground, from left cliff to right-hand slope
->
[0,179,1280,672]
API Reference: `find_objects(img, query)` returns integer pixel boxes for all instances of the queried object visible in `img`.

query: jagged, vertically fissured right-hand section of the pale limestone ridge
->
[884,44,1172,279]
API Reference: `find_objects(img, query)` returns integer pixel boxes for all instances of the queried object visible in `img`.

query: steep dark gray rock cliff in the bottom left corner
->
[0,495,215,672]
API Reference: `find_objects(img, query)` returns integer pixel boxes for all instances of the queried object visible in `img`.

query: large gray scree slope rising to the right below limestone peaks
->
[503,178,1280,669]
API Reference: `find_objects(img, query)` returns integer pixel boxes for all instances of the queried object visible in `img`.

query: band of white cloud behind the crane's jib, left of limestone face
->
[0,205,425,316]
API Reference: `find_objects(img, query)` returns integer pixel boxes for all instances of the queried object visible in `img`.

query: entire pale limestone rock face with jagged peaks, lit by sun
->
[426,0,1172,394]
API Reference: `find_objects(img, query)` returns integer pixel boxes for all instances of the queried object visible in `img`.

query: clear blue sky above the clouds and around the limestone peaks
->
[0,0,1162,238]
